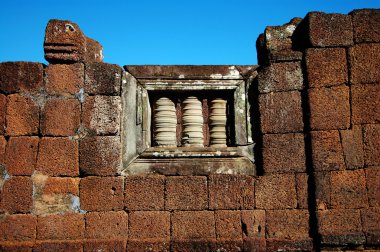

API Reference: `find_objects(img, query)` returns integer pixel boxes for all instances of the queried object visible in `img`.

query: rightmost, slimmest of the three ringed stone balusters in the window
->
[209,98,227,147]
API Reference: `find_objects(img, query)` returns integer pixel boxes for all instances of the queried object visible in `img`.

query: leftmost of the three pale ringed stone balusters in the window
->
[154,97,177,147]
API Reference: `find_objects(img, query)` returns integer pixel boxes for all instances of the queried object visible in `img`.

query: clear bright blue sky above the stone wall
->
[0,0,380,66]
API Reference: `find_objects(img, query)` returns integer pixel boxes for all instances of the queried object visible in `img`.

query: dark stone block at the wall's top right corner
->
[350,9,380,43]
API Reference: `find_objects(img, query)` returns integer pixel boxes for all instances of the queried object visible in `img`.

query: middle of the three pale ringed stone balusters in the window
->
[182,96,203,147]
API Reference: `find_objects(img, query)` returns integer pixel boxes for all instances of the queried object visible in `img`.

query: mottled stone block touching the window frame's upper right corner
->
[258,62,303,93]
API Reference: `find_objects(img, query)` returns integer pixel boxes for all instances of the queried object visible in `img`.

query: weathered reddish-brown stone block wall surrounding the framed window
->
[0,10,380,251]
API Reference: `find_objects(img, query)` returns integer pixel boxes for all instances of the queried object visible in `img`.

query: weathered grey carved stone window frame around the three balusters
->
[122,66,256,175]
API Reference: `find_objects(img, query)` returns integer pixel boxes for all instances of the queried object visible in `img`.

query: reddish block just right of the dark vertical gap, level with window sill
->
[311,130,345,171]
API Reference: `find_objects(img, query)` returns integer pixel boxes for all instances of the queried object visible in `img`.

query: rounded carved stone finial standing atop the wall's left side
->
[44,19,103,63]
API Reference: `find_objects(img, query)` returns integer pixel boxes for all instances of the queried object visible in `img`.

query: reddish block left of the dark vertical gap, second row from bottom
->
[266,209,309,240]
